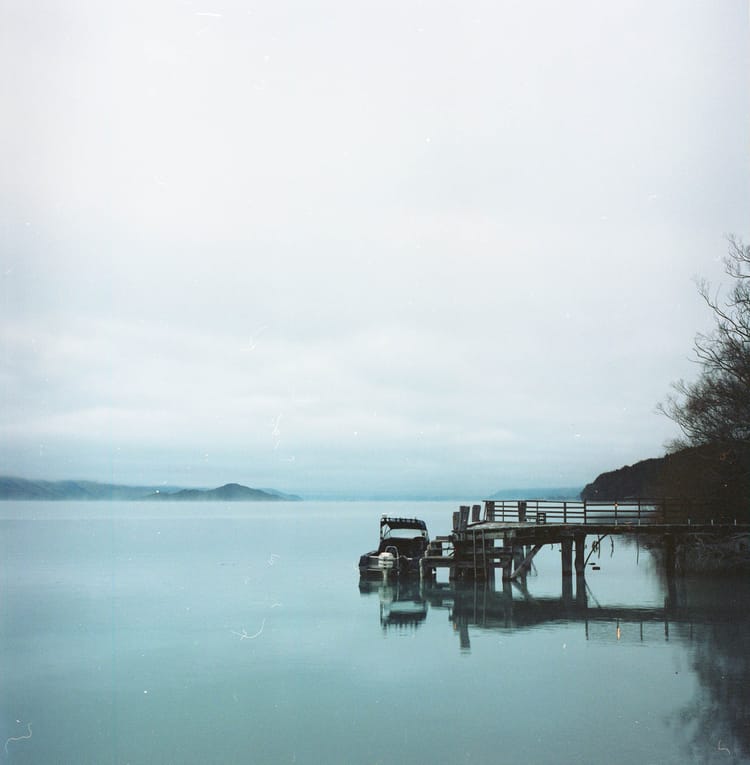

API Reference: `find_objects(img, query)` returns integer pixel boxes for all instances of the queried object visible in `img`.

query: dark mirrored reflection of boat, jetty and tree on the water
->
[360,577,750,762]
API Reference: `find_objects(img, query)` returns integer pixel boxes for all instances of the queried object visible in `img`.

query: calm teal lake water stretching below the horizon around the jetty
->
[0,502,750,765]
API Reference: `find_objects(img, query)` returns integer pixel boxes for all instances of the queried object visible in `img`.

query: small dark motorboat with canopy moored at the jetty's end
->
[359,515,430,577]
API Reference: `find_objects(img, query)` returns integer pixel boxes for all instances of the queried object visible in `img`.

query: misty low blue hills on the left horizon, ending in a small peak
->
[0,476,301,502]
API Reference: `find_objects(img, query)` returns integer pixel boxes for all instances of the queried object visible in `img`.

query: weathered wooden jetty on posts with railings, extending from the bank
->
[420,499,750,581]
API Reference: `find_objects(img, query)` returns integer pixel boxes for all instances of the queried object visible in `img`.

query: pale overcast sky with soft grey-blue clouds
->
[0,0,750,500]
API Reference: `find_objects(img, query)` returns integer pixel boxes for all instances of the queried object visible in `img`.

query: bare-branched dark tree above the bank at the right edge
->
[658,237,750,451]
